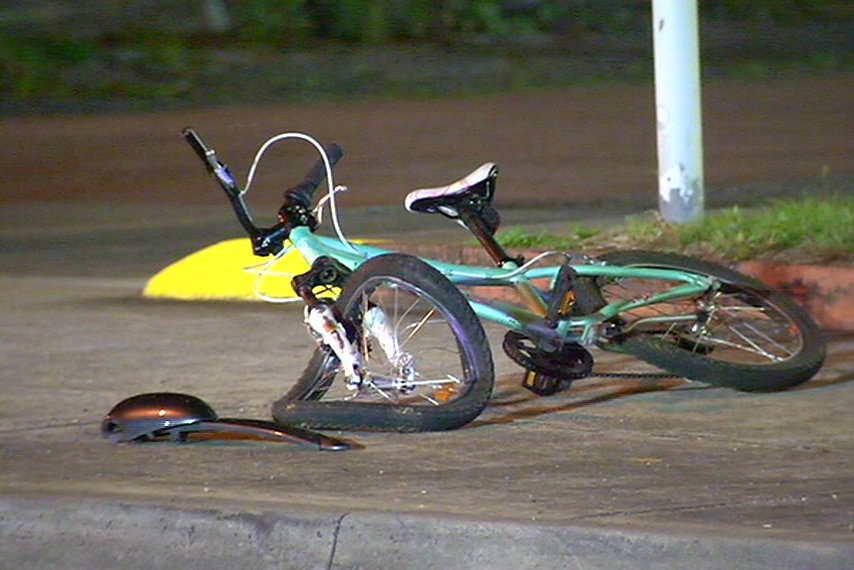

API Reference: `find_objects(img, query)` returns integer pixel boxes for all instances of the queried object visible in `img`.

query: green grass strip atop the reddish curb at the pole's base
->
[498,195,854,263]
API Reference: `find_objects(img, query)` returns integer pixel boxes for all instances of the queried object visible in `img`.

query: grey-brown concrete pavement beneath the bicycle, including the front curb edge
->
[0,202,854,569]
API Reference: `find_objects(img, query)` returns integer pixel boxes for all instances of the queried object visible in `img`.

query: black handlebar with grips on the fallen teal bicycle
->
[182,127,344,256]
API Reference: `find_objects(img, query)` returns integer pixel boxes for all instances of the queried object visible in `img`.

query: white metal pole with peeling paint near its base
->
[652,0,704,223]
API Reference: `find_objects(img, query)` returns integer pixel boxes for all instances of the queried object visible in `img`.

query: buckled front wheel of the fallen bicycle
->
[273,254,494,431]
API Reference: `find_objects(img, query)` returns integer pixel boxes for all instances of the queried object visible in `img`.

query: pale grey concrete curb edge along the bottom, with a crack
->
[0,497,854,570]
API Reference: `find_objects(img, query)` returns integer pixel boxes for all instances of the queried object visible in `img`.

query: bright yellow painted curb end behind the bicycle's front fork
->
[142,238,309,301]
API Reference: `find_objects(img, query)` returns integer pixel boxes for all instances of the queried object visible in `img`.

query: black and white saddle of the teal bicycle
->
[404,162,498,219]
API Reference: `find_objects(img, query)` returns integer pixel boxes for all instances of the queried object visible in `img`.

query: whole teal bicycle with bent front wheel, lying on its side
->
[183,127,825,431]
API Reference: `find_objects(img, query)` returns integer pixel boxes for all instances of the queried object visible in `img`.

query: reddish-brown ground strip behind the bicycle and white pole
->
[0,71,854,213]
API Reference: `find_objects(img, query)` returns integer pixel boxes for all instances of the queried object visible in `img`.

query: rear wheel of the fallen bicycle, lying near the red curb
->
[596,251,825,391]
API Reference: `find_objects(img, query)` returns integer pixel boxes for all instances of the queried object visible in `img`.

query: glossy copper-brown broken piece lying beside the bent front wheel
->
[101,392,356,450]
